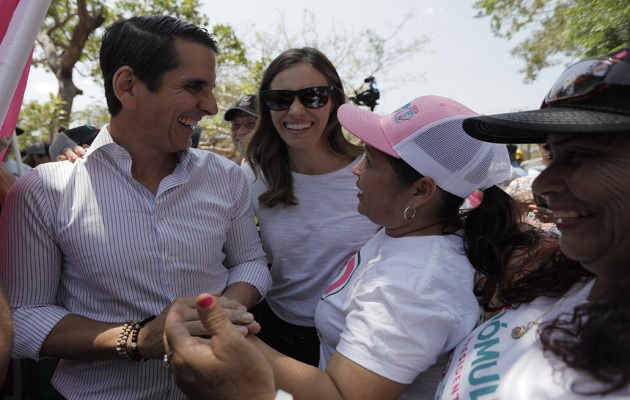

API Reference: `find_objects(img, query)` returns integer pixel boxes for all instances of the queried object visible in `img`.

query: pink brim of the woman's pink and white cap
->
[337,104,400,158]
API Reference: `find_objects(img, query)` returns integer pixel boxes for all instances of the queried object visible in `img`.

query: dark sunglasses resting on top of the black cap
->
[543,57,630,107]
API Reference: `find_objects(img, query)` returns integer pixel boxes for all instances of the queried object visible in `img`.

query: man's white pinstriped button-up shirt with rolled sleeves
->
[0,128,271,400]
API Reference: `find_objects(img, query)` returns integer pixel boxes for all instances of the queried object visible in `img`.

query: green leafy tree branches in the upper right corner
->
[473,0,630,82]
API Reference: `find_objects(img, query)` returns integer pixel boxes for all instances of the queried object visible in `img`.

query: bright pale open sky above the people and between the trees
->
[26,0,563,114]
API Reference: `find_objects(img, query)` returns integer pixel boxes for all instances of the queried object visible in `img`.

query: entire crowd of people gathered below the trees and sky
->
[0,12,630,399]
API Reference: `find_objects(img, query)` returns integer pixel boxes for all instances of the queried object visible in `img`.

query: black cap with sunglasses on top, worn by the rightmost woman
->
[463,47,630,143]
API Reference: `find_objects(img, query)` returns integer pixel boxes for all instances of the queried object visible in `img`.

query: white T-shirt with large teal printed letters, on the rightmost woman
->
[435,282,592,400]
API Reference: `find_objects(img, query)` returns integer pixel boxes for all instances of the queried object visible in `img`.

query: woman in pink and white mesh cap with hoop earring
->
[242,96,540,400]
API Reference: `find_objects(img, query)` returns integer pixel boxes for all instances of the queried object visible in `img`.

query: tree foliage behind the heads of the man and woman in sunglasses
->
[24,0,427,155]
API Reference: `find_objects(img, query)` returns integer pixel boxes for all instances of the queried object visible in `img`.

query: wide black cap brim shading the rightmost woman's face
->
[463,107,630,143]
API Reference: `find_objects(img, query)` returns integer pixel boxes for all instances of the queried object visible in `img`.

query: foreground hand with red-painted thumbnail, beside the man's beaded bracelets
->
[164,294,275,400]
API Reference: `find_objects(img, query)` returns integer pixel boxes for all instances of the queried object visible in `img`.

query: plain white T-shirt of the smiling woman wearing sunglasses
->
[243,157,378,327]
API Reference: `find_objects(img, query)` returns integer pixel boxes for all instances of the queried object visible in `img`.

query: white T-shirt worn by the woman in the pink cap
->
[315,230,479,400]
